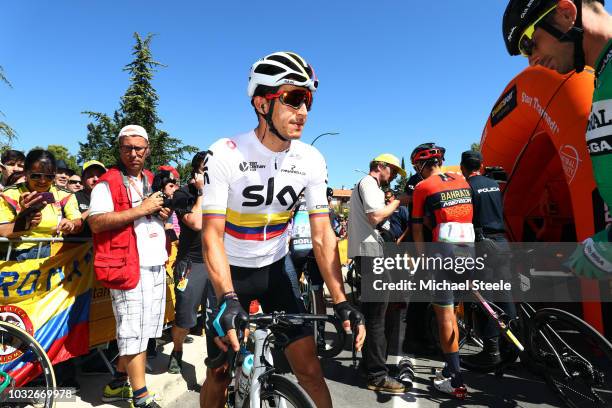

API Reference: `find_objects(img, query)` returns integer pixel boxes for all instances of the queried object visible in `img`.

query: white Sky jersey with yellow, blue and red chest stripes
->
[202,131,329,268]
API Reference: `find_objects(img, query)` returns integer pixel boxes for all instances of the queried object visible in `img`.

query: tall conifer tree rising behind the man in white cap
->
[79,33,198,169]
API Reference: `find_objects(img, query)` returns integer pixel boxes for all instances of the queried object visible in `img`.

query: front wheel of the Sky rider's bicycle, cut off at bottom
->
[242,374,315,408]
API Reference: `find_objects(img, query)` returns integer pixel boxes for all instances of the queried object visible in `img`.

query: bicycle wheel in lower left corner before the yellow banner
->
[0,321,56,408]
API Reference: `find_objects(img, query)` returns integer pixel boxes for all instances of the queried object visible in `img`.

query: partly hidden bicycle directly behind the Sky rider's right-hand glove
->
[300,257,346,358]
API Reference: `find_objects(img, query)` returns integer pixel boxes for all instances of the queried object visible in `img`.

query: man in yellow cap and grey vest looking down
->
[348,153,407,394]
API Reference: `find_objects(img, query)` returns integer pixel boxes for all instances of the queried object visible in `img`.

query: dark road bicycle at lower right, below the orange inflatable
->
[430,293,612,408]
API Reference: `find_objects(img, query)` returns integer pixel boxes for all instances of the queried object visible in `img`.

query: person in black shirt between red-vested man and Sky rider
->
[168,152,214,374]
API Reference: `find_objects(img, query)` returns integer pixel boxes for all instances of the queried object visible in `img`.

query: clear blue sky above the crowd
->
[0,0,564,187]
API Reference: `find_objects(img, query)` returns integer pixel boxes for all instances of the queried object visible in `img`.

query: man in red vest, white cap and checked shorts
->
[88,125,170,408]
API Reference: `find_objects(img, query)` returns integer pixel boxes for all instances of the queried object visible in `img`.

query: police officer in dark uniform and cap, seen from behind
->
[461,150,516,366]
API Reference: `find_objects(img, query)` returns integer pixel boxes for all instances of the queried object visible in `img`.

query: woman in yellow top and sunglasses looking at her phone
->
[0,149,81,261]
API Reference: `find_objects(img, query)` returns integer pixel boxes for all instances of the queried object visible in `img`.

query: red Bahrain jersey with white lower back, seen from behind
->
[412,172,474,242]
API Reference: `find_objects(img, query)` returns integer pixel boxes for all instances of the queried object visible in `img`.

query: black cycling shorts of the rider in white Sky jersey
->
[206,256,313,368]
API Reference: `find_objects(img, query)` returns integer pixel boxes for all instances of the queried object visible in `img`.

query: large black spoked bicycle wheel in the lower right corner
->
[530,309,612,408]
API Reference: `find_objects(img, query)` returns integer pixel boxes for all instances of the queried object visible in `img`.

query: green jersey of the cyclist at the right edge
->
[586,40,612,212]
